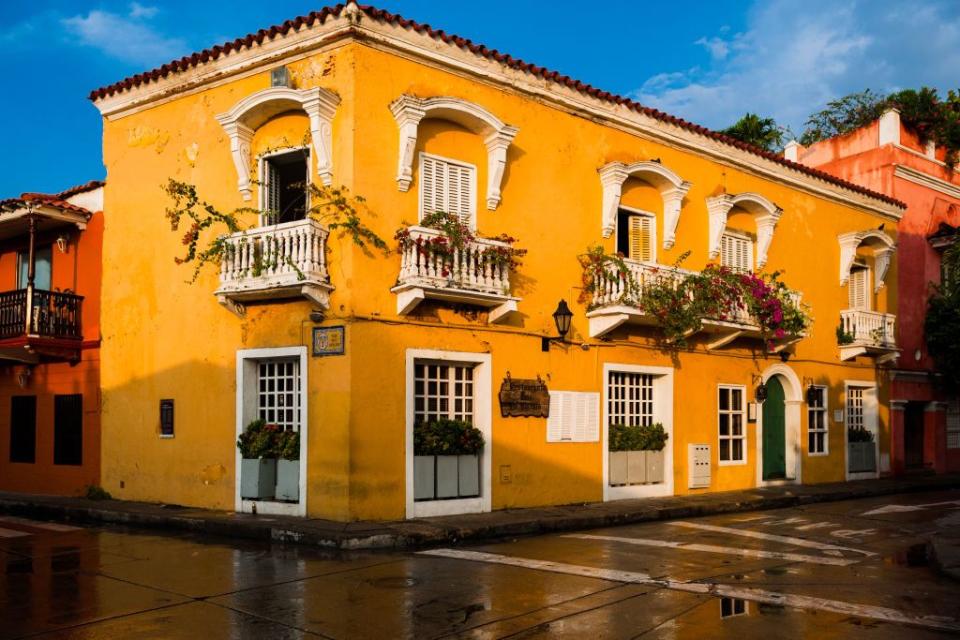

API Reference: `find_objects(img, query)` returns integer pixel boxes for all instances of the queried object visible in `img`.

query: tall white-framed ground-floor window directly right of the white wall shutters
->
[602,363,673,500]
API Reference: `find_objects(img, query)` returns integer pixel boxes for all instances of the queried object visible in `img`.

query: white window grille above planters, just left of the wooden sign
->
[413,362,473,424]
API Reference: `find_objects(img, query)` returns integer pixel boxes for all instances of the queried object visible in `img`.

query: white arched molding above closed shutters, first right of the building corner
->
[390,94,518,211]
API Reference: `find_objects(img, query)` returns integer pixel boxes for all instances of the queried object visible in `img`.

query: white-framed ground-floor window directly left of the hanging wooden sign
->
[405,349,493,518]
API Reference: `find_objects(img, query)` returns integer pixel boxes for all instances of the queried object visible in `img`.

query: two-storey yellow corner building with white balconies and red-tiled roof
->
[91,3,903,520]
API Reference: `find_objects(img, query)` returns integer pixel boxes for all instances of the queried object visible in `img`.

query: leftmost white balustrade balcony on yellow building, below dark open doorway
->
[215,218,333,315]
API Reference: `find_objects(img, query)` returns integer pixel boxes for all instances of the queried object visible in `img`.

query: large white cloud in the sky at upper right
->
[635,0,960,133]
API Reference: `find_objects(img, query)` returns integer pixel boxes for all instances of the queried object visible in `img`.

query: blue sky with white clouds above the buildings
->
[0,0,960,197]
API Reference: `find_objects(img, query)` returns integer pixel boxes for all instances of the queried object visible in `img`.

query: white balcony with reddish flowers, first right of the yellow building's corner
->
[391,227,520,322]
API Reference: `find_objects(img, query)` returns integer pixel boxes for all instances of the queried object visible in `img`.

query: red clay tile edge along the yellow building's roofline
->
[89,0,907,209]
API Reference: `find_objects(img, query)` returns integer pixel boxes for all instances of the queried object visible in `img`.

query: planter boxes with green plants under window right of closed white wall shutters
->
[609,422,670,486]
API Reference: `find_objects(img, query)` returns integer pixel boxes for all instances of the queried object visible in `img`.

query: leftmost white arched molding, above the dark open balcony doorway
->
[217,87,340,200]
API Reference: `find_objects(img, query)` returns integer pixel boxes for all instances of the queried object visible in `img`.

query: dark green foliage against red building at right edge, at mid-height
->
[924,232,960,390]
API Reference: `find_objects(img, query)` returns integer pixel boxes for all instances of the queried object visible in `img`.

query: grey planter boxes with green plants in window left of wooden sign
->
[413,418,484,500]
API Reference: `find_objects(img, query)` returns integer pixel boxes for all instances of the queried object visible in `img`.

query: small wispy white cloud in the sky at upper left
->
[62,3,188,65]
